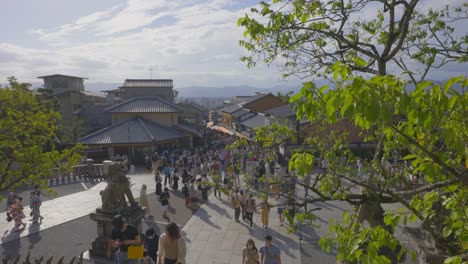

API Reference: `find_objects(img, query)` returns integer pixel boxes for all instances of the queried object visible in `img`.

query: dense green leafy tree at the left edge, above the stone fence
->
[0,77,82,197]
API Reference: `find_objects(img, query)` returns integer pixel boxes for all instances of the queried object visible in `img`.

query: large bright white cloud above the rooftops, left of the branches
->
[0,0,286,87]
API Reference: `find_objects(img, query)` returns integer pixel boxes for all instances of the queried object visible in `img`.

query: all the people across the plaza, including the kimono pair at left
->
[7,131,295,264]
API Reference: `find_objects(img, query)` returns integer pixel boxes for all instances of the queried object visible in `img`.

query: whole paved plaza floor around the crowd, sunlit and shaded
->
[0,168,416,264]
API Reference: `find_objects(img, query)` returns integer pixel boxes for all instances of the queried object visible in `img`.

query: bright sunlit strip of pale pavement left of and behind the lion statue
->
[0,174,155,244]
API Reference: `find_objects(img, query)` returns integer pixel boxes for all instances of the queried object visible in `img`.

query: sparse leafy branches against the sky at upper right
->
[238,0,468,80]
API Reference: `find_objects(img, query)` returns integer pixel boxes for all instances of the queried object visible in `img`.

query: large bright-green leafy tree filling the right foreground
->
[238,0,468,263]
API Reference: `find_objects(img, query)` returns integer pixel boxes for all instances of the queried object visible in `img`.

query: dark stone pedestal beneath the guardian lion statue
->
[89,206,146,261]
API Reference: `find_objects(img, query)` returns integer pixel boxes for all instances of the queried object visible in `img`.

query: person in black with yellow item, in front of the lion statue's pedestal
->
[107,215,141,264]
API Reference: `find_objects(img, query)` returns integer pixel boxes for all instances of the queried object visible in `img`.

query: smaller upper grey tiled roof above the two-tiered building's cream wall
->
[105,97,183,113]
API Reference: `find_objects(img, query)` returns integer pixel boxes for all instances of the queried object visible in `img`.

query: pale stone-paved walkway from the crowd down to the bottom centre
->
[182,194,301,264]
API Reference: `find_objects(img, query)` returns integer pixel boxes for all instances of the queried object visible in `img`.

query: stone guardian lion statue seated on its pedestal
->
[100,162,137,211]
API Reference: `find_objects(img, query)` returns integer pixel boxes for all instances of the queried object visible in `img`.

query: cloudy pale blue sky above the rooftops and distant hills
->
[0,0,466,88]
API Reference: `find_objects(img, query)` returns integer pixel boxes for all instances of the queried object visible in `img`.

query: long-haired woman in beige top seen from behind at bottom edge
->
[158,222,187,264]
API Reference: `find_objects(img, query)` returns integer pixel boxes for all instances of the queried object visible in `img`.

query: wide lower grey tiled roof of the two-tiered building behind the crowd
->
[79,117,184,145]
